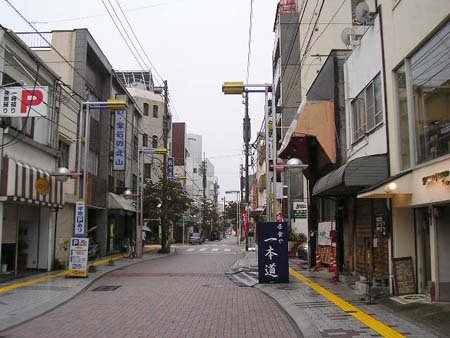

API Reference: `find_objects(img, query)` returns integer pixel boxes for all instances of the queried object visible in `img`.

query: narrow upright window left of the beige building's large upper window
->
[396,65,411,170]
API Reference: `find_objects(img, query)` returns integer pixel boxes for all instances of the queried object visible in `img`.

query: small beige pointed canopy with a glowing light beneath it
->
[357,171,413,198]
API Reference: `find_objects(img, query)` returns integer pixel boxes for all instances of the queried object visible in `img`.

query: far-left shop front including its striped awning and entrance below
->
[0,157,63,278]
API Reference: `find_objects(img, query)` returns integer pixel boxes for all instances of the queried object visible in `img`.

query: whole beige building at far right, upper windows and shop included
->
[358,0,450,301]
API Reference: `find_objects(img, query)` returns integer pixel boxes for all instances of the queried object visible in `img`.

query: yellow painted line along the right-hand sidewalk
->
[289,268,406,338]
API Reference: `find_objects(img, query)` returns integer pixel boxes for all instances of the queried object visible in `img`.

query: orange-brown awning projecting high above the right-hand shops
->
[278,101,336,163]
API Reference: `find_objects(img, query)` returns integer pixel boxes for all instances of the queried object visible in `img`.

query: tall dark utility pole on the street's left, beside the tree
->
[161,80,170,251]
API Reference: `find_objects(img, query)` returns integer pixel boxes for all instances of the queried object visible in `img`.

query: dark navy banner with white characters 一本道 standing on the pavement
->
[257,222,289,283]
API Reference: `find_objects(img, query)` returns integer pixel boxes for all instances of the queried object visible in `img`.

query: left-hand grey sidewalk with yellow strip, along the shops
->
[0,250,174,332]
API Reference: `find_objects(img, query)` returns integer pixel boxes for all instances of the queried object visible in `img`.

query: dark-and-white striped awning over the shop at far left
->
[1,157,64,208]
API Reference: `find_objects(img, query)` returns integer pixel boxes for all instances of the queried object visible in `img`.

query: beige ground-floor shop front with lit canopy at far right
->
[358,159,450,301]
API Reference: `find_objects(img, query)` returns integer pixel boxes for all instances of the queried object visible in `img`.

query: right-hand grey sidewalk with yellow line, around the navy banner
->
[232,252,450,337]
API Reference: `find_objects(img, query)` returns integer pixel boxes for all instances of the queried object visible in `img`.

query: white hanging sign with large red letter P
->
[0,86,48,117]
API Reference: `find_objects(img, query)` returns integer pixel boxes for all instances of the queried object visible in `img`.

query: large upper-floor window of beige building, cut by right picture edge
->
[411,23,450,163]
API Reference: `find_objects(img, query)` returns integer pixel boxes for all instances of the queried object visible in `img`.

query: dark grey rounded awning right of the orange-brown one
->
[313,154,389,196]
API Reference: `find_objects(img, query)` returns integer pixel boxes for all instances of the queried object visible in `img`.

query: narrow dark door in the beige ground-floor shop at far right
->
[415,208,431,294]
